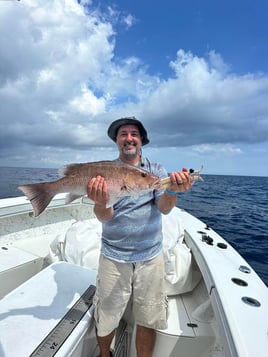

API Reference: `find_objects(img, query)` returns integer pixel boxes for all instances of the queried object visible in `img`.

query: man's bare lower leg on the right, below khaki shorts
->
[136,325,156,357]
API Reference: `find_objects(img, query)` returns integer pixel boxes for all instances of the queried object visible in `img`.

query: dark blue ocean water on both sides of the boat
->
[0,167,268,286]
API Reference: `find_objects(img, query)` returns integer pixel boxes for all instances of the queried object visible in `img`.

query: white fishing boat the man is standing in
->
[0,194,268,357]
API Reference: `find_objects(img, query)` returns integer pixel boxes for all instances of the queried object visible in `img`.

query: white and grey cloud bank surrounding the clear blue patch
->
[0,0,268,175]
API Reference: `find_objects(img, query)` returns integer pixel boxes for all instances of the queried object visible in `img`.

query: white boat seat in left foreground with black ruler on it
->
[0,262,97,357]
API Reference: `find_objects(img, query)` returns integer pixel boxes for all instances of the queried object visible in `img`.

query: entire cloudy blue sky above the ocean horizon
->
[0,0,268,176]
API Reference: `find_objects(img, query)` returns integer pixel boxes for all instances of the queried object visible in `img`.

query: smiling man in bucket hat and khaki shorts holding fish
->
[88,117,191,357]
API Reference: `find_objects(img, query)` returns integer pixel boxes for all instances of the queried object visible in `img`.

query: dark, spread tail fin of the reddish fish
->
[18,182,55,217]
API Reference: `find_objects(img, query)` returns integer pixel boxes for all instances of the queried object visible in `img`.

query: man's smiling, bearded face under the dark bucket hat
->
[116,125,142,159]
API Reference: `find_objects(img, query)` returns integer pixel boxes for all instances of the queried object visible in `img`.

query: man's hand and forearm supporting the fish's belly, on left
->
[87,176,114,221]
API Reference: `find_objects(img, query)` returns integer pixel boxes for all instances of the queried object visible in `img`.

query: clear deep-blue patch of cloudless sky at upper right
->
[113,0,268,75]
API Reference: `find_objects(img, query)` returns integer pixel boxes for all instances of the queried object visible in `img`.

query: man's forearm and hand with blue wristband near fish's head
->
[157,171,192,214]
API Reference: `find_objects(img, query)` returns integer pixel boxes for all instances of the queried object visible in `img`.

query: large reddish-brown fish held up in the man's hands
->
[18,161,161,217]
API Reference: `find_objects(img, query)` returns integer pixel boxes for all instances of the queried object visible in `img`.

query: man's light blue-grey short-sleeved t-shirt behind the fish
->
[101,159,167,263]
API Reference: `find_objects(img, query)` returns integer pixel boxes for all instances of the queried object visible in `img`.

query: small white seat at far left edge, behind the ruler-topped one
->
[0,246,44,299]
